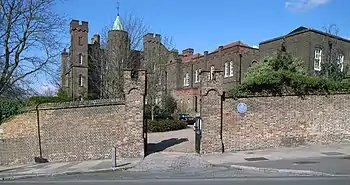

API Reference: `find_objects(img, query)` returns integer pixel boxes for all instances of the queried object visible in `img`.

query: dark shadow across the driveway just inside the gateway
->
[147,138,188,155]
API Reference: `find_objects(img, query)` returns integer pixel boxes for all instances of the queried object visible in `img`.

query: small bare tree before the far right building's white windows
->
[319,24,349,81]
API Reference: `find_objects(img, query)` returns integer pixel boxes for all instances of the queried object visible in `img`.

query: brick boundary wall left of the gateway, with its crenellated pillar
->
[0,70,146,165]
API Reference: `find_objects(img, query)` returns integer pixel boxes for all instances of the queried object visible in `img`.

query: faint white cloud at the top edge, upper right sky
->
[284,0,331,12]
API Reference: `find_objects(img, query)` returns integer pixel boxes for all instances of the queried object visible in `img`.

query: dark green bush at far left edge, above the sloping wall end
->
[0,101,25,124]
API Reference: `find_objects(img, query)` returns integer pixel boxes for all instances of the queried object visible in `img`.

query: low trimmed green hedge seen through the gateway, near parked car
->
[147,119,187,132]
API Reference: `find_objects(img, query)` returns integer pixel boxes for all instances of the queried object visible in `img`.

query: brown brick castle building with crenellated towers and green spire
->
[61,15,350,115]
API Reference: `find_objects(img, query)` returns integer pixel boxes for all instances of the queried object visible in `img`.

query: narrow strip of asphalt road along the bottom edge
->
[0,177,350,185]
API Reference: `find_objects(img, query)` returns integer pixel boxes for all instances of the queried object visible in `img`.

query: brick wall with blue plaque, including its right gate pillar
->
[200,71,350,153]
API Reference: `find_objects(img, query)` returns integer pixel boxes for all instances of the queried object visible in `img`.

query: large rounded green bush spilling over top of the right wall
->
[231,48,350,98]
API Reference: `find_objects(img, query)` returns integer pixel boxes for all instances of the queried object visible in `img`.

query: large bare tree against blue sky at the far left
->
[0,0,65,98]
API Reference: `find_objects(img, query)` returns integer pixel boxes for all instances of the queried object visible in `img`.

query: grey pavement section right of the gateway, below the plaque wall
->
[202,145,350,176]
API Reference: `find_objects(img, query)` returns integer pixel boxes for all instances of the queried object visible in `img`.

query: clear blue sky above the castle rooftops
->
[37,0,350,94]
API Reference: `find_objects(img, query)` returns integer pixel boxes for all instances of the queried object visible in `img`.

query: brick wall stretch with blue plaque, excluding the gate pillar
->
[223,94,350,151]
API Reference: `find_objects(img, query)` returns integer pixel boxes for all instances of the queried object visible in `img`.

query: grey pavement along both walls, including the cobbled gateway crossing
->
[0,144,350,180]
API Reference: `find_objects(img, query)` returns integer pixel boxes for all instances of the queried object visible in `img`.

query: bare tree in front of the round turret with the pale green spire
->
[89,13,149,98]
